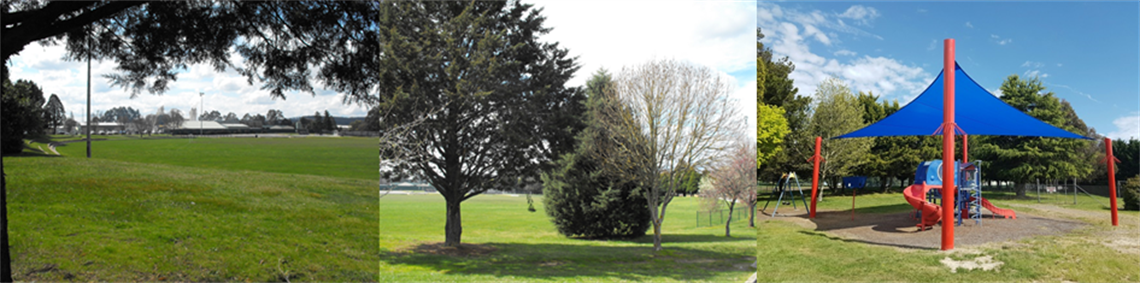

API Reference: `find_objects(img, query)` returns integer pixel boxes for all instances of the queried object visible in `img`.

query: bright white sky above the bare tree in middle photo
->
[523,0,756,139]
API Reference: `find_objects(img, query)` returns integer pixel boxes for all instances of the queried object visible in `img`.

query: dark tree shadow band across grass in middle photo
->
[381,237,755,281]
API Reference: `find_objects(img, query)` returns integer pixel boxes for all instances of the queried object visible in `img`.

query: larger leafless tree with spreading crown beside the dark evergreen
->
[599,59,744,250]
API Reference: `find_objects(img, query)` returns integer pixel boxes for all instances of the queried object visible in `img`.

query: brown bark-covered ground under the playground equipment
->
[775,206,1088,249]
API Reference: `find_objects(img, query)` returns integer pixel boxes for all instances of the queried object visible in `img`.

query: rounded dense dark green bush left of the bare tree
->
[543,153,650,238]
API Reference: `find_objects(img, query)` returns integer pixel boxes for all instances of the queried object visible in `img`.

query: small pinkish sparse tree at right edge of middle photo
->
[701,140,756,237]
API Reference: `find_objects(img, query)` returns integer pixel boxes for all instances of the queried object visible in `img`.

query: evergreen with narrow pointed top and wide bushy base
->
[543,70,650,238]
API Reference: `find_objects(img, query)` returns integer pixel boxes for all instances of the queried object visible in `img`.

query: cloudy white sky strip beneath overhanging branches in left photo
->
[8,40,367,122]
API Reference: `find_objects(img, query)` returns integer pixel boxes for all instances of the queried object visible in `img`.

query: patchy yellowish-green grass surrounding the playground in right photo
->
[757,187,1140,282]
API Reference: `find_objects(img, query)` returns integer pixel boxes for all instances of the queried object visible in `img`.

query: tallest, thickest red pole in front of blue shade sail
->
[942,39,956,251]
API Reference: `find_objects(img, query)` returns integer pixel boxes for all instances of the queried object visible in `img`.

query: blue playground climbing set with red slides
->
[903,160,1017,229]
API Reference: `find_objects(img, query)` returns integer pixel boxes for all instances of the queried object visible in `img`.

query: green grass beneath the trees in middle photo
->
[380,194,756,282]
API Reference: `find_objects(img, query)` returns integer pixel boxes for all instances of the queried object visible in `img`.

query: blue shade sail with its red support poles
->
[808,39,1119,250]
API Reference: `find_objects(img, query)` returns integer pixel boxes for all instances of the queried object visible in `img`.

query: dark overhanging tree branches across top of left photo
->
[0,0,380,102]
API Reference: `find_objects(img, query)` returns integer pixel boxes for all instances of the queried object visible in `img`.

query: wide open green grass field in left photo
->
[3,138,380,282]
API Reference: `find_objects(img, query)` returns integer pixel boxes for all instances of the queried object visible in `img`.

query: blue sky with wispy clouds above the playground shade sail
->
[756,1,1140,139]
